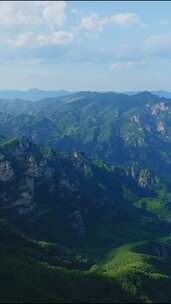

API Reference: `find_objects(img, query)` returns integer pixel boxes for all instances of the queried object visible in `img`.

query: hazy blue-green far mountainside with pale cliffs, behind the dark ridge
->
[0,92,171,181]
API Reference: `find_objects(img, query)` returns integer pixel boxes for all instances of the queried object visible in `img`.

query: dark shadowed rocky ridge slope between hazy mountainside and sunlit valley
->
[0,138,170,255]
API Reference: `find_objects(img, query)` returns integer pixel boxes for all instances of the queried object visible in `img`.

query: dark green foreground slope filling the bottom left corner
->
[0,220,133,303]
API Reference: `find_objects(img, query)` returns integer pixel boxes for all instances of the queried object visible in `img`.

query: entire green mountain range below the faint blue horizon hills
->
[0,92,171,303]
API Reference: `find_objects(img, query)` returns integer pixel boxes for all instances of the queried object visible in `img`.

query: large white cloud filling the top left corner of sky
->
[0,1,66,28]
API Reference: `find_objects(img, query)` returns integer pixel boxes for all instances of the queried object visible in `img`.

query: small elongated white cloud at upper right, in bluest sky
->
[81,13,142,31]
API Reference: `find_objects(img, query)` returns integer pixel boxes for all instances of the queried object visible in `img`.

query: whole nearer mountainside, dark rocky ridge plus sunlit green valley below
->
[0,138,171,303]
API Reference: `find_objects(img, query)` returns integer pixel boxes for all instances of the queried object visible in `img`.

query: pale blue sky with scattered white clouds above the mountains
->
[0,1,171,91]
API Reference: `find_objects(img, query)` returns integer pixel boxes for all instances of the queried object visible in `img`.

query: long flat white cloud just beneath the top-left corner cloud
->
[0,31,73,48]
